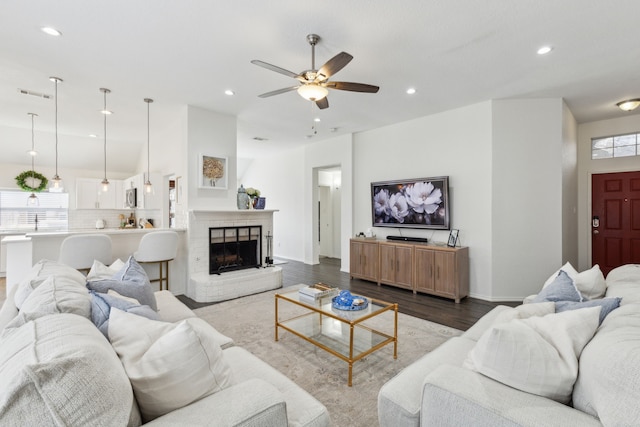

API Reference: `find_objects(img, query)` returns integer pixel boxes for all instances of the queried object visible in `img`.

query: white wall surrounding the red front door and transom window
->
[576,114,640,271]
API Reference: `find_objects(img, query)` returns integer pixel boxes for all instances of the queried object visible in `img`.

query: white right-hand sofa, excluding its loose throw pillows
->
[378,265,640,427]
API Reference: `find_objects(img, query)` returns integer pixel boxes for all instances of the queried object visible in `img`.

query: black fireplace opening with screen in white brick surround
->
[209,225,262,274]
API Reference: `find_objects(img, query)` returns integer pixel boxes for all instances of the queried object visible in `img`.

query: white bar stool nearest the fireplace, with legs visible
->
[133,231,178,290]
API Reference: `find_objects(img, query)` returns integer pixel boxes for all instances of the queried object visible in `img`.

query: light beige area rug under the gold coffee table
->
[194,288,462,427]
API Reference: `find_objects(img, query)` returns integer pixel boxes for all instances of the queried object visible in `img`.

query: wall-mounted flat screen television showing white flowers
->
[371,176,451,230]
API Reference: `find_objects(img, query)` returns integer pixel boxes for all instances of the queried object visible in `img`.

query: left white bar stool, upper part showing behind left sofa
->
[58,234,112,272]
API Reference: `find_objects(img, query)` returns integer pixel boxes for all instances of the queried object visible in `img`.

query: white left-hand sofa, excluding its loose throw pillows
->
[0,262,330,426]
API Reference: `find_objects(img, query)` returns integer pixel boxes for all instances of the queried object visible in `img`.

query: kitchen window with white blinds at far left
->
[0,190,69,232]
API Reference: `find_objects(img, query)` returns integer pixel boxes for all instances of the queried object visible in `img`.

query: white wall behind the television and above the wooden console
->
[352,102,492,298]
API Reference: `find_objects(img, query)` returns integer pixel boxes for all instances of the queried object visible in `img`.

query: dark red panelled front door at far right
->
[591,172,640,276]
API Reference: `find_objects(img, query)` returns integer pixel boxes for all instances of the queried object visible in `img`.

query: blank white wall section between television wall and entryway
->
[492,98,563,300]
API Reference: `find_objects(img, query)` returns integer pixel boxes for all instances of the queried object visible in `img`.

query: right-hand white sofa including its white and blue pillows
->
[378,264,640,427]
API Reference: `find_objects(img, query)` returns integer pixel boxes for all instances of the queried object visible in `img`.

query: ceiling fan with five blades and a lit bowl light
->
[251,34,380,109]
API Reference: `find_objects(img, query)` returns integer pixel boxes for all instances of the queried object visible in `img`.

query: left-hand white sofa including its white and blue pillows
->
[0,259,330,427]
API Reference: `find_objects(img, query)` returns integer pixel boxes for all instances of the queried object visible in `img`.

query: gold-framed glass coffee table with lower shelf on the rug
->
[275,290,398,387]
